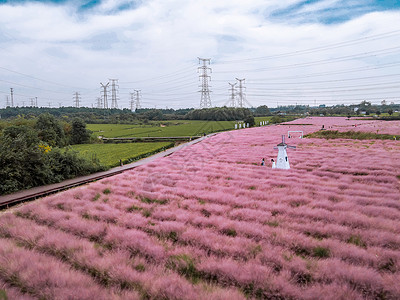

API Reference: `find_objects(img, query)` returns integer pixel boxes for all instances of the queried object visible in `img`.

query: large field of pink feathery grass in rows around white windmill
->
[0,118,400,299]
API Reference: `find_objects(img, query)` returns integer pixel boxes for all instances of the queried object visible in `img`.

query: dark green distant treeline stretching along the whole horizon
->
[0,101,400,124]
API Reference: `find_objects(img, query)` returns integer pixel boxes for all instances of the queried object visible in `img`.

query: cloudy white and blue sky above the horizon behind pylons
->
[0,0,400,108]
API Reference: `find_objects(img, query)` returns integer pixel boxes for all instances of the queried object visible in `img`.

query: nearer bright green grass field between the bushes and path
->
[72,142,173,168]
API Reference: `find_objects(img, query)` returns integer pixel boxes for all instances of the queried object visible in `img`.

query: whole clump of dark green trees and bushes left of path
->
[0,114,105,195]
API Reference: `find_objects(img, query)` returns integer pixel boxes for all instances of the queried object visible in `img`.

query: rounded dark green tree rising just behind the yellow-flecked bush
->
[35,113,66,147]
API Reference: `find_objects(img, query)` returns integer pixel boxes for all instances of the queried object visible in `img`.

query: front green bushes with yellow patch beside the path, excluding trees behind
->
[0,125,104,195]
